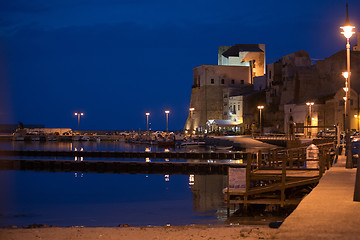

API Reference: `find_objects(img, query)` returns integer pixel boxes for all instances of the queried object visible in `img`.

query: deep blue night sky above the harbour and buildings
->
[0,0,360,130]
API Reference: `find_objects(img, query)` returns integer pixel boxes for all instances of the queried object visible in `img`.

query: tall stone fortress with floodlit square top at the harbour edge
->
[184,44,265,134]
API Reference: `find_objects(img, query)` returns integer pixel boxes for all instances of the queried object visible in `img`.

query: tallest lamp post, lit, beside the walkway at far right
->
[340,4,355,168]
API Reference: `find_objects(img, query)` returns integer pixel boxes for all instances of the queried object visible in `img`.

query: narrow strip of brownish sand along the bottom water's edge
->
[0,226,277,240]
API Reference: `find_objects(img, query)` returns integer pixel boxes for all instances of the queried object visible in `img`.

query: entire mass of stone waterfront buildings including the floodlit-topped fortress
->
[184,33,360,135]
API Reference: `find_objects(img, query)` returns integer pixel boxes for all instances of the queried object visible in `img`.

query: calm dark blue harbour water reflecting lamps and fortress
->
[0,142,231,227]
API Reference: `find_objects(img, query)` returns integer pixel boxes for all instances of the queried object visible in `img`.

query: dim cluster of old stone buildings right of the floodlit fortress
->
[266,41,360,135]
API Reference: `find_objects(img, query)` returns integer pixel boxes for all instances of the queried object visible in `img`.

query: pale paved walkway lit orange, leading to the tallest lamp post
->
[275,155,360,240]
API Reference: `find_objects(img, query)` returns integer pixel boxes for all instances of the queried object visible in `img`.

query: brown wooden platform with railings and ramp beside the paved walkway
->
[224,144,332,209]
